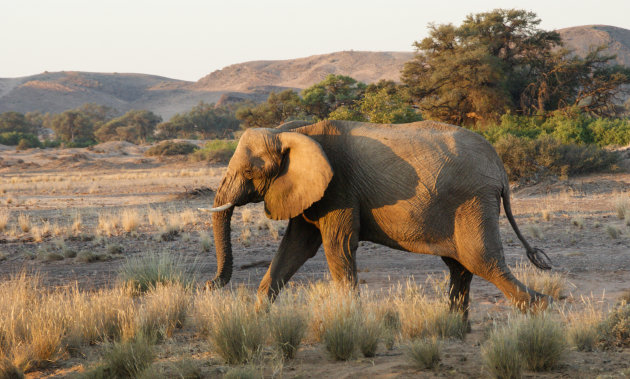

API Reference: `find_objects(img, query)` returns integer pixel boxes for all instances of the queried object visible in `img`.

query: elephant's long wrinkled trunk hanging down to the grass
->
[206,186,234,289]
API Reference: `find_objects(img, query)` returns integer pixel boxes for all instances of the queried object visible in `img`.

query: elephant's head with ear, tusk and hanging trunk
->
[207,129,333,288]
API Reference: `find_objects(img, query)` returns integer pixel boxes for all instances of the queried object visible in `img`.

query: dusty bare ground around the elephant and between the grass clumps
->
[0,143,630,378]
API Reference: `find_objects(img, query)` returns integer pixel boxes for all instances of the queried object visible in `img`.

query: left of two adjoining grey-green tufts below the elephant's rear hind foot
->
[481,327,524,379]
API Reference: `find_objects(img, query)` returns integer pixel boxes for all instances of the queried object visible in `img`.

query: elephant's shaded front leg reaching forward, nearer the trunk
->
[258,215,322,306]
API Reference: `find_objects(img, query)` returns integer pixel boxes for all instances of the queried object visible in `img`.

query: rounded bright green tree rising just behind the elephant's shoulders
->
[302,74,366,120]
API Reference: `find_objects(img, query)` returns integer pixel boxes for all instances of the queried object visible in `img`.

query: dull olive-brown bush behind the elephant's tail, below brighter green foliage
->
[494,134,618,180]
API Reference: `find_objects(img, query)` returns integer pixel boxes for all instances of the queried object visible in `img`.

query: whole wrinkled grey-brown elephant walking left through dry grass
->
[207,121,550,317]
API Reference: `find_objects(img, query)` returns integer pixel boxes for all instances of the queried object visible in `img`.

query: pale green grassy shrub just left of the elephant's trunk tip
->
[119,253,196,292]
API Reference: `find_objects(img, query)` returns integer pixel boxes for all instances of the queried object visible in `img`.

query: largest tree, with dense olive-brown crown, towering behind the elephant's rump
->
[402,9,630,125]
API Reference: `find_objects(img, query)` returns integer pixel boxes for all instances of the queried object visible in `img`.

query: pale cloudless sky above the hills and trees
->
[0,0,630,81]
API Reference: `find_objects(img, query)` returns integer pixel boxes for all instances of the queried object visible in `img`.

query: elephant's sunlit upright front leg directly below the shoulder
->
[320,209,359,288]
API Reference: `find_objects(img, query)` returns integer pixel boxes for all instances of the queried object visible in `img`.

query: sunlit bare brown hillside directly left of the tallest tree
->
[194,51,413,92]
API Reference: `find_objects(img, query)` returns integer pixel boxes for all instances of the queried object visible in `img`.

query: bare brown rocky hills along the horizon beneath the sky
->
[0,25,630,119]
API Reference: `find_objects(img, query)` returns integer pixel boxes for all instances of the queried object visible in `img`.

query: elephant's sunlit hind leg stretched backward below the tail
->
[455,199,551,311]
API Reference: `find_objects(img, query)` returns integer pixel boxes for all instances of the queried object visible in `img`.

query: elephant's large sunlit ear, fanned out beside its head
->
[265,132,333,220]
